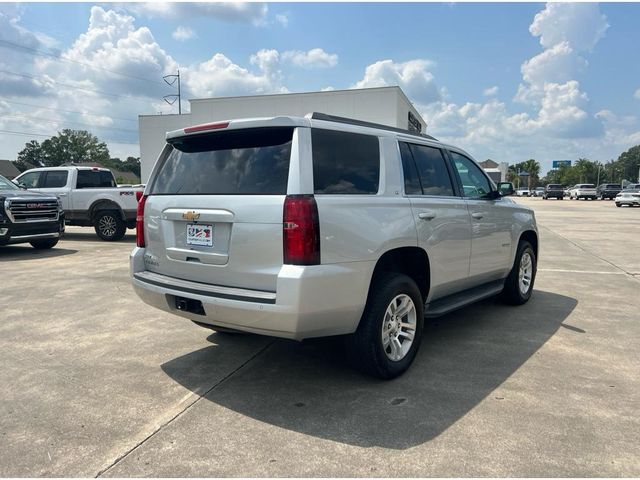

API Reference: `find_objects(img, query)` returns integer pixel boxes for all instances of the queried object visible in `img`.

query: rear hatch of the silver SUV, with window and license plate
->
[145,127,294,292]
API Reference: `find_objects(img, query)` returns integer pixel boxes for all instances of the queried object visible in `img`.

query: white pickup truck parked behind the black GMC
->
[13,167,144,241]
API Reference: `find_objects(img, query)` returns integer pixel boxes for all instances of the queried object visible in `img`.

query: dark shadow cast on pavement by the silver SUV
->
[162,290,577,449]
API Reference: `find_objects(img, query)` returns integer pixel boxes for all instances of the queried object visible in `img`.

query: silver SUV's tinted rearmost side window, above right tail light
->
[311,128,380,195]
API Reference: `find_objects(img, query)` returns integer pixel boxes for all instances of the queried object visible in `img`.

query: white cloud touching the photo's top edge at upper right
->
[529,3,609,51]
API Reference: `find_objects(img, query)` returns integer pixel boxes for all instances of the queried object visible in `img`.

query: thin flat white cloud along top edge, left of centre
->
[121,2,268,25]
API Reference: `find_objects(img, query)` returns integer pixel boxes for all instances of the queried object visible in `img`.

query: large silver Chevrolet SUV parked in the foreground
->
[131,113,538,378]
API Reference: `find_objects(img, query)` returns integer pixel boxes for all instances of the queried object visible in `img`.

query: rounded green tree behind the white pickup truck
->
[18,129,110,167]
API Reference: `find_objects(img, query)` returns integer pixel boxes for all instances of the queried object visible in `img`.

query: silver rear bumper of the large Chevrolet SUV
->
[130,248,375,340]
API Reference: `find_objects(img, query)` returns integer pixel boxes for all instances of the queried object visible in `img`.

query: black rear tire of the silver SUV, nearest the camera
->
[345,273,424,379]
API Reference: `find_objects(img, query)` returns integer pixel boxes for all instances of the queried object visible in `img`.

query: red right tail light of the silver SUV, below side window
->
[282,195,320,265]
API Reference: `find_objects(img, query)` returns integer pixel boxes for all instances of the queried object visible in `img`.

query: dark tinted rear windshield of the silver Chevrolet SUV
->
[151,127,293,195]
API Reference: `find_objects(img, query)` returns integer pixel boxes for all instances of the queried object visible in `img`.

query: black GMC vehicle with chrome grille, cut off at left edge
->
[0,176,64,249]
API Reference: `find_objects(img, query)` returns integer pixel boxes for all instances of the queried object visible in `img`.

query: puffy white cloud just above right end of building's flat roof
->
[352,59,442,105]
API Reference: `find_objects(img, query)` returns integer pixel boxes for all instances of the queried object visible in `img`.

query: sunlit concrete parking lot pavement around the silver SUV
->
[0,198,640,477]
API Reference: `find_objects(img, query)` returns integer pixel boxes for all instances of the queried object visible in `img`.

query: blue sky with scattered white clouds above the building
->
[0,3,640,171]
